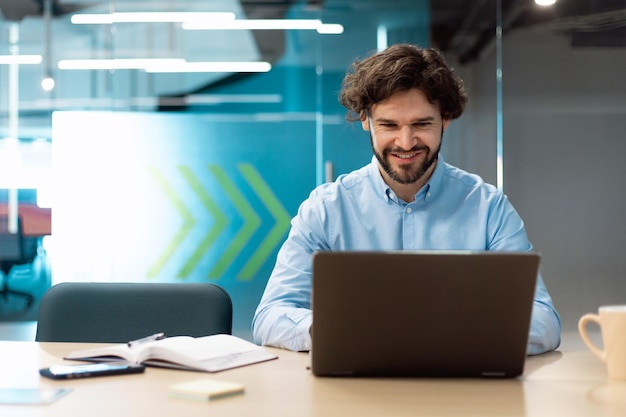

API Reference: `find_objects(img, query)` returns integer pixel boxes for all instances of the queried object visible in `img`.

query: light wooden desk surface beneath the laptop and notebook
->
[0,342,626,417]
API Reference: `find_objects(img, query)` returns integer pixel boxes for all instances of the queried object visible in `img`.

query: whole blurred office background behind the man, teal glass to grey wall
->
[0,0,626,338]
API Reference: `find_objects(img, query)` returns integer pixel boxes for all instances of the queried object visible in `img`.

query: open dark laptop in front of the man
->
[311,251,540,378]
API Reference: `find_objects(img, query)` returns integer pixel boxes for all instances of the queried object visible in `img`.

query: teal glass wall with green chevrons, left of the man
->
[0,0,429,334]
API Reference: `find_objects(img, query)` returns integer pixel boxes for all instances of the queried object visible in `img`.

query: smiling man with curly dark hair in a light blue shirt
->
[252,45,561,354]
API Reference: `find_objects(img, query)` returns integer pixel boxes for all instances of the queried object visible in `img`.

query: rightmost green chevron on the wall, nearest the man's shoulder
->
[238,164,291,281]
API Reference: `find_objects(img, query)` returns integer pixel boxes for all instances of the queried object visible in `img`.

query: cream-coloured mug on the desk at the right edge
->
[578,305,626,380]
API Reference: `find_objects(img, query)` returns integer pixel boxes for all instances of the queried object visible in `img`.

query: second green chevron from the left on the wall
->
[178,166,228,278]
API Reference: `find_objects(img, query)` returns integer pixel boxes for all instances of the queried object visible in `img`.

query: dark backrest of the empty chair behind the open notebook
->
[35,282,233,343]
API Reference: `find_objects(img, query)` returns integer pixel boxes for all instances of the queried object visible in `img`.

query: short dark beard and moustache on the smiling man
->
[370,136,443,185]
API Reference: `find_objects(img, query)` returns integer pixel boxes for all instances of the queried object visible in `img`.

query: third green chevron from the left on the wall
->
[209,165,261,278]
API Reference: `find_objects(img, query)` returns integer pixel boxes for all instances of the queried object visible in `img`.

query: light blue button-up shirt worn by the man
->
[252,155,561,355]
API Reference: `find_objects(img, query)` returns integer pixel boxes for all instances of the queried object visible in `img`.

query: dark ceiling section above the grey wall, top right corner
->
[431,0,626,63]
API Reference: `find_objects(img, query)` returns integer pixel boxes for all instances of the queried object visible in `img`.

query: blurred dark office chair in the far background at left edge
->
[0,215,37,308]
